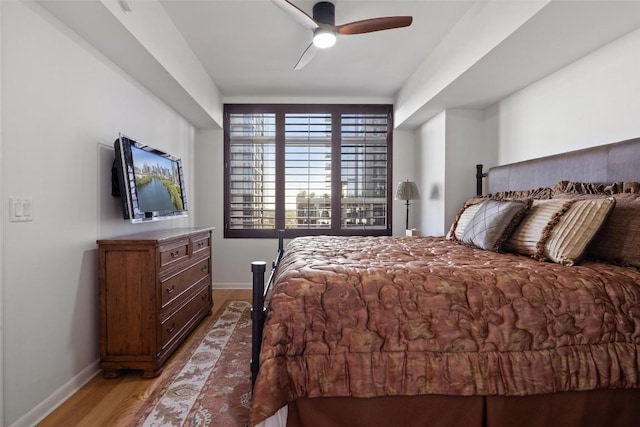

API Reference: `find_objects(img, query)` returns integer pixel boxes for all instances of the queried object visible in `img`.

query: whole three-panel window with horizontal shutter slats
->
[224,104,393,237]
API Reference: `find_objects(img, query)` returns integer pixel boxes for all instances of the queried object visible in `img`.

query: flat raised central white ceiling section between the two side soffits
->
[161,0,473,97]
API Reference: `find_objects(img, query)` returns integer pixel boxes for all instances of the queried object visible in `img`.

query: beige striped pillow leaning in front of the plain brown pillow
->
[543,197,616,265]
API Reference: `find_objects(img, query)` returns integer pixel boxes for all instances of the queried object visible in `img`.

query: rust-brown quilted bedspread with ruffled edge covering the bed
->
[251,236,640,424]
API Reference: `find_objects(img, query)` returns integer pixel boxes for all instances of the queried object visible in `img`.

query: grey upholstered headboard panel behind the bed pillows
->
[488,138,640,193]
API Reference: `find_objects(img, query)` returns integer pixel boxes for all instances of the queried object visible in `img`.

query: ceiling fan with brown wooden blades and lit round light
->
[271,0,413,70]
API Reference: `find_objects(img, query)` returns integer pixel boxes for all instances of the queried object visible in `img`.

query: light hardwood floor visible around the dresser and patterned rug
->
[38,289,251,427]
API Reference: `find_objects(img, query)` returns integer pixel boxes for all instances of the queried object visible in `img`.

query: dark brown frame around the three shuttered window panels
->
[223,104,393,238]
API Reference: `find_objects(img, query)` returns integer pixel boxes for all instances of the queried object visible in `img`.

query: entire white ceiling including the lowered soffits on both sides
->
[39,0,640,128]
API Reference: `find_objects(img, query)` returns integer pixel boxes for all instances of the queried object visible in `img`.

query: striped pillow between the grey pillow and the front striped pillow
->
[504,200,574,259]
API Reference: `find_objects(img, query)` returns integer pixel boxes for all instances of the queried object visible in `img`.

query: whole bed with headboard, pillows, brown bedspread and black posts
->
[250,139,640,427]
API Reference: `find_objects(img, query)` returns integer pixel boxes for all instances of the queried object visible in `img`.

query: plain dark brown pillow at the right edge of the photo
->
[588,193,640,267]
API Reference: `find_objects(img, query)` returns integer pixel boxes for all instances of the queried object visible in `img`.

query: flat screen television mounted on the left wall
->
[112,134,188,222]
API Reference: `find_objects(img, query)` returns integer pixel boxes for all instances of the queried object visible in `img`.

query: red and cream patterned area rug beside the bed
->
[135,301,251,427]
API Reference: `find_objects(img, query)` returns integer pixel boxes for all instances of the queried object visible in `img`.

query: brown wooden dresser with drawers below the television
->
[98,228,213,378]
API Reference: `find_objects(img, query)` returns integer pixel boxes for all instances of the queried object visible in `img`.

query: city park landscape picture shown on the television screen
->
[131,145,184,212]
